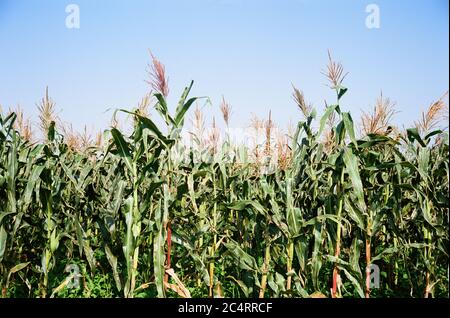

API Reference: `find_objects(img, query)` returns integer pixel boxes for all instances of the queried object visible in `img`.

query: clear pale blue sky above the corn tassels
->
[0,0,449,134]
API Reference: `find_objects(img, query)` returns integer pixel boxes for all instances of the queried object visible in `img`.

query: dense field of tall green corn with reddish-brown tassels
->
[0,57,449,298]
